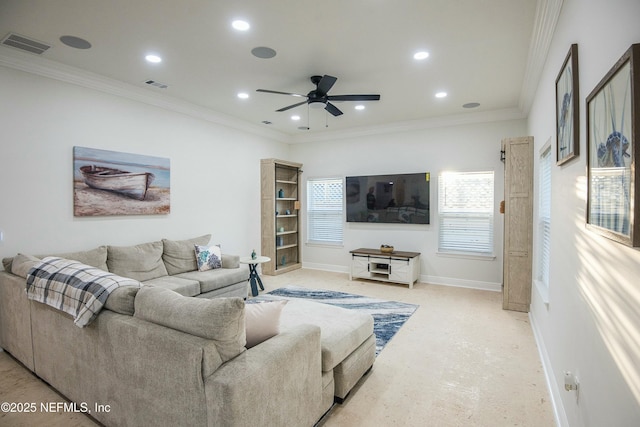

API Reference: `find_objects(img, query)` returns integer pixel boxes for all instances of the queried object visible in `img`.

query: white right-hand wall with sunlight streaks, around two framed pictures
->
[528,0,640,426]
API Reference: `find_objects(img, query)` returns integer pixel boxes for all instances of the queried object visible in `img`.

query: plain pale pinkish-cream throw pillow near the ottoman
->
[244,300,287,348]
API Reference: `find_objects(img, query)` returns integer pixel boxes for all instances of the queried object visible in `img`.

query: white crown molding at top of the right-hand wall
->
[519,0,564,115]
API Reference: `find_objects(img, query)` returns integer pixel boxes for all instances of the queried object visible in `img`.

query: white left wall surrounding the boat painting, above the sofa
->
[0,66,288,257]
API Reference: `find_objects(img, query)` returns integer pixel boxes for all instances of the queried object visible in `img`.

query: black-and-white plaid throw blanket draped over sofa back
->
[27,257,141,328]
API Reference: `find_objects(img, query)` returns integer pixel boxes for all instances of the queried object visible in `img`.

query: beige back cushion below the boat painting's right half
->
[107,241,167,282]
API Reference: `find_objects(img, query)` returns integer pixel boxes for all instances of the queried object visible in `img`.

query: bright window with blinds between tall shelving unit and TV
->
[307,178,344,245]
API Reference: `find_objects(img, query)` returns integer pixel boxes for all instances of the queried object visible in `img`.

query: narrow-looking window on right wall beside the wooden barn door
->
[536,146,551,288]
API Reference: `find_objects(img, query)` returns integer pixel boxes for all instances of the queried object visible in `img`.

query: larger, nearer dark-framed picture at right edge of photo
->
[587,44,640,247]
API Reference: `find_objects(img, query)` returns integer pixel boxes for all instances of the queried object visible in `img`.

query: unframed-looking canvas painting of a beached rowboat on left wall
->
[73,147,171,216]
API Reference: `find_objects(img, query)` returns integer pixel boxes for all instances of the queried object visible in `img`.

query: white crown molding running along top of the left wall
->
[0,46,290,143]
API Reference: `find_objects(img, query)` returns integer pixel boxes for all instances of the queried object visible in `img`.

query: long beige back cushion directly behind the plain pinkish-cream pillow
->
[134,286,247,362]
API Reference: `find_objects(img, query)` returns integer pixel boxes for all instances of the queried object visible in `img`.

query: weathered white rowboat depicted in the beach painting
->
[80,165,155,200]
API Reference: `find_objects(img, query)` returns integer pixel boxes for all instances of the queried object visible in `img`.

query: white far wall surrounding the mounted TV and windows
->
[291,120,525,290]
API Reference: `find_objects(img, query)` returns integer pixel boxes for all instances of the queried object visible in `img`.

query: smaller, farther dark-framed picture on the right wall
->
[556,44,580,165]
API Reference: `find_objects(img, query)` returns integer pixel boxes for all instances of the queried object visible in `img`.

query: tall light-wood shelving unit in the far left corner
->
[260,159,302,275]
